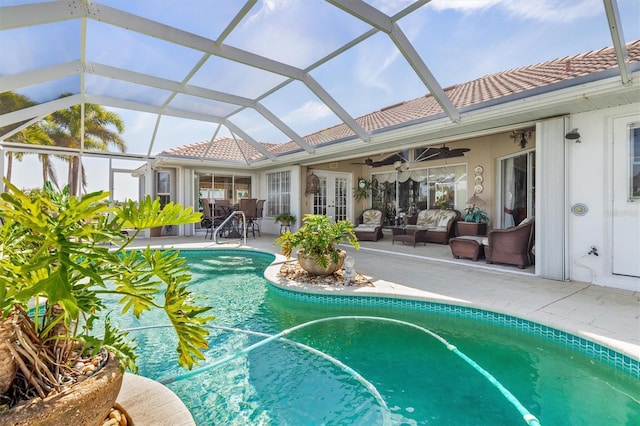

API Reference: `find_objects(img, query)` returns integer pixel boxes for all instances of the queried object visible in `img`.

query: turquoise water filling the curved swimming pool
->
[107,250,640,425]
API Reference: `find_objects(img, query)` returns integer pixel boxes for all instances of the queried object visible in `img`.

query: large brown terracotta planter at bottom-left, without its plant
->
[0,355,123,426]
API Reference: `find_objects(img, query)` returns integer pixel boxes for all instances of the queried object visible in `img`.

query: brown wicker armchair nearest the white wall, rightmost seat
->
[484,218,535,269]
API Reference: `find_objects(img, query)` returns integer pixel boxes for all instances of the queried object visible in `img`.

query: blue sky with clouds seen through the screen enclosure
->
[0,0,640,199]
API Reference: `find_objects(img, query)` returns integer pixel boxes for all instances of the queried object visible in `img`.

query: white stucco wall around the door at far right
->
[566,104,640,291]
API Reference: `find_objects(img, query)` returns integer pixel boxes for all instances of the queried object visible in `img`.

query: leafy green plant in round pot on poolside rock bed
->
[274,214,360,276]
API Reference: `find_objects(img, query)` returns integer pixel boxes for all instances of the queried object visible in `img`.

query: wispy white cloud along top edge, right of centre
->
[429,0,602,23]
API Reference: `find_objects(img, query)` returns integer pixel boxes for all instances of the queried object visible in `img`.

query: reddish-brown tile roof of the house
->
[160,40,640,161]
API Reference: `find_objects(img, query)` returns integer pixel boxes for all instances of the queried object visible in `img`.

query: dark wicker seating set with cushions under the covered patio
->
[355,209,535,269]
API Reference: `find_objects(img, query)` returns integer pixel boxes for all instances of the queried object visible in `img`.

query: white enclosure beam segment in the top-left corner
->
[0,0,82,31]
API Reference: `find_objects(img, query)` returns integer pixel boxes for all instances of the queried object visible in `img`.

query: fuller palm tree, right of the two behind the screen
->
[45,93,127,194]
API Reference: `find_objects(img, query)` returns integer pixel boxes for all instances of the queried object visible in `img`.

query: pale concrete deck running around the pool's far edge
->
[123,234,640,425]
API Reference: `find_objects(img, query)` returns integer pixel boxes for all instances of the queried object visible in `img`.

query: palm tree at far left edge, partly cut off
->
[0,92,58,190]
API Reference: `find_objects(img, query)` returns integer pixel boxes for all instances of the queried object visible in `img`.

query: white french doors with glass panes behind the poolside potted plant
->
[310,170,352,221]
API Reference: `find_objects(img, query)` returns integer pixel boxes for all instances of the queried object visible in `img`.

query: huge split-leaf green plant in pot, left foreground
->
[0,180,213,425]
